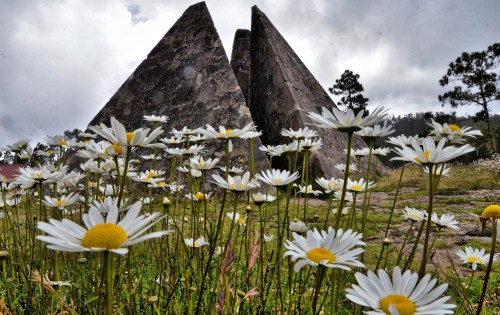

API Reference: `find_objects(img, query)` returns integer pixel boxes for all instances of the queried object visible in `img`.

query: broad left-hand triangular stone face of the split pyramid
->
[89,2,269,170]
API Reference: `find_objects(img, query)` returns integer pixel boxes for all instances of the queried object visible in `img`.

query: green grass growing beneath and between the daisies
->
[0,156,500,314]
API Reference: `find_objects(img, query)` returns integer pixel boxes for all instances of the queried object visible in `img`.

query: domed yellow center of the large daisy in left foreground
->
[82,223,128,249]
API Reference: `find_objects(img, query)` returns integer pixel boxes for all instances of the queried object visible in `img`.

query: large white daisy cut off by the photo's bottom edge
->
[346,267,456,315]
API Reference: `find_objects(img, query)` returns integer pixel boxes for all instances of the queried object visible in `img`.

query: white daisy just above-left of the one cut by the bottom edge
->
[283,227,365,272]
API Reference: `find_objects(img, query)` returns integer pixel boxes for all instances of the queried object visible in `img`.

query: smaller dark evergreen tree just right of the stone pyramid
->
[328,70,368,114]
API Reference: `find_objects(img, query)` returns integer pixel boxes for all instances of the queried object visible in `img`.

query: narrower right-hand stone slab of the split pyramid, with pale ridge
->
[240,6,380,177]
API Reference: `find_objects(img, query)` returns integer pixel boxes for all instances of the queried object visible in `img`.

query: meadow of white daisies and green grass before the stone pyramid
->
[0,108,500,315]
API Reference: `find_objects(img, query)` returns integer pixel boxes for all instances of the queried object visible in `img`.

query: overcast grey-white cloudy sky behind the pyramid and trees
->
[0,0,500,147]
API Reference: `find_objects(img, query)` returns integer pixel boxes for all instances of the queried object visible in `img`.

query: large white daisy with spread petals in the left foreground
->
[36,202,172,255]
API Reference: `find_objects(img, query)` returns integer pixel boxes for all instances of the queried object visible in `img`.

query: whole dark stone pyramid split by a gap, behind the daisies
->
[89,2,382,177]
